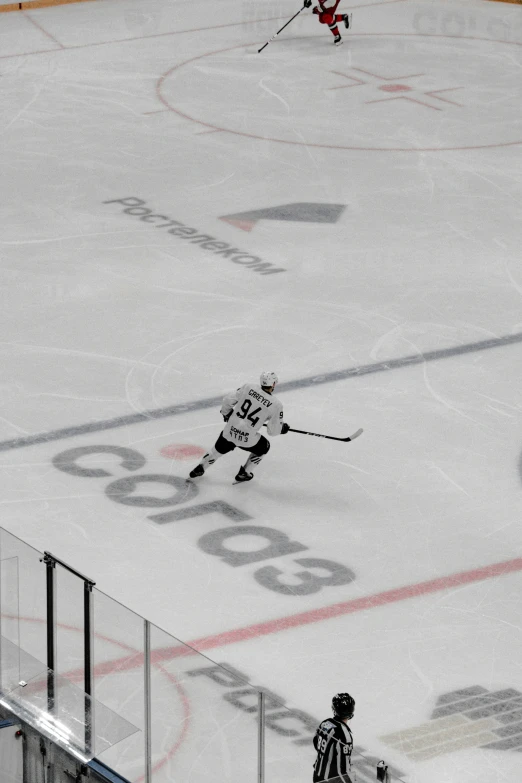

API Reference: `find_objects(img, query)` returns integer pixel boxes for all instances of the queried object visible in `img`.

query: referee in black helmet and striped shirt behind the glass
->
[313,693,355,783]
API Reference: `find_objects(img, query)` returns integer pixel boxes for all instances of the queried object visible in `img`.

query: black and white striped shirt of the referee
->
[314,718,353,783]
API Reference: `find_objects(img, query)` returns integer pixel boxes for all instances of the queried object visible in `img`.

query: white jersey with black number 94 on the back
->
[221,383,283,448]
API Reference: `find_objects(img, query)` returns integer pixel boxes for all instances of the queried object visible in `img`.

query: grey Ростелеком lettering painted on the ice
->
[103,196,287,275]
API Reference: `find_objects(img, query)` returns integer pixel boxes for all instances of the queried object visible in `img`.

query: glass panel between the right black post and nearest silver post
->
[93,589,145,783]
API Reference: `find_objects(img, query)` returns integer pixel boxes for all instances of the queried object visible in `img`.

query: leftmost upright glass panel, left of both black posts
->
[0,528,47,661]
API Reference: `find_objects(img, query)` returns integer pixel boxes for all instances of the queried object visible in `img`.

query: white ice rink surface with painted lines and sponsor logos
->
[0,0,522,783]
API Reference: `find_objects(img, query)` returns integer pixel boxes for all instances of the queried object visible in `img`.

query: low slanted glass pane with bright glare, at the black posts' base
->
[0,642,138,761]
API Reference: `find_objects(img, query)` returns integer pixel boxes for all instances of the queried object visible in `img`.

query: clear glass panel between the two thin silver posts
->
[151,626,256,783]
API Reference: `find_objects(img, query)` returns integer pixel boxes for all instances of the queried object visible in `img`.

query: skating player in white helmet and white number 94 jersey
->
[189,372,290,481]
